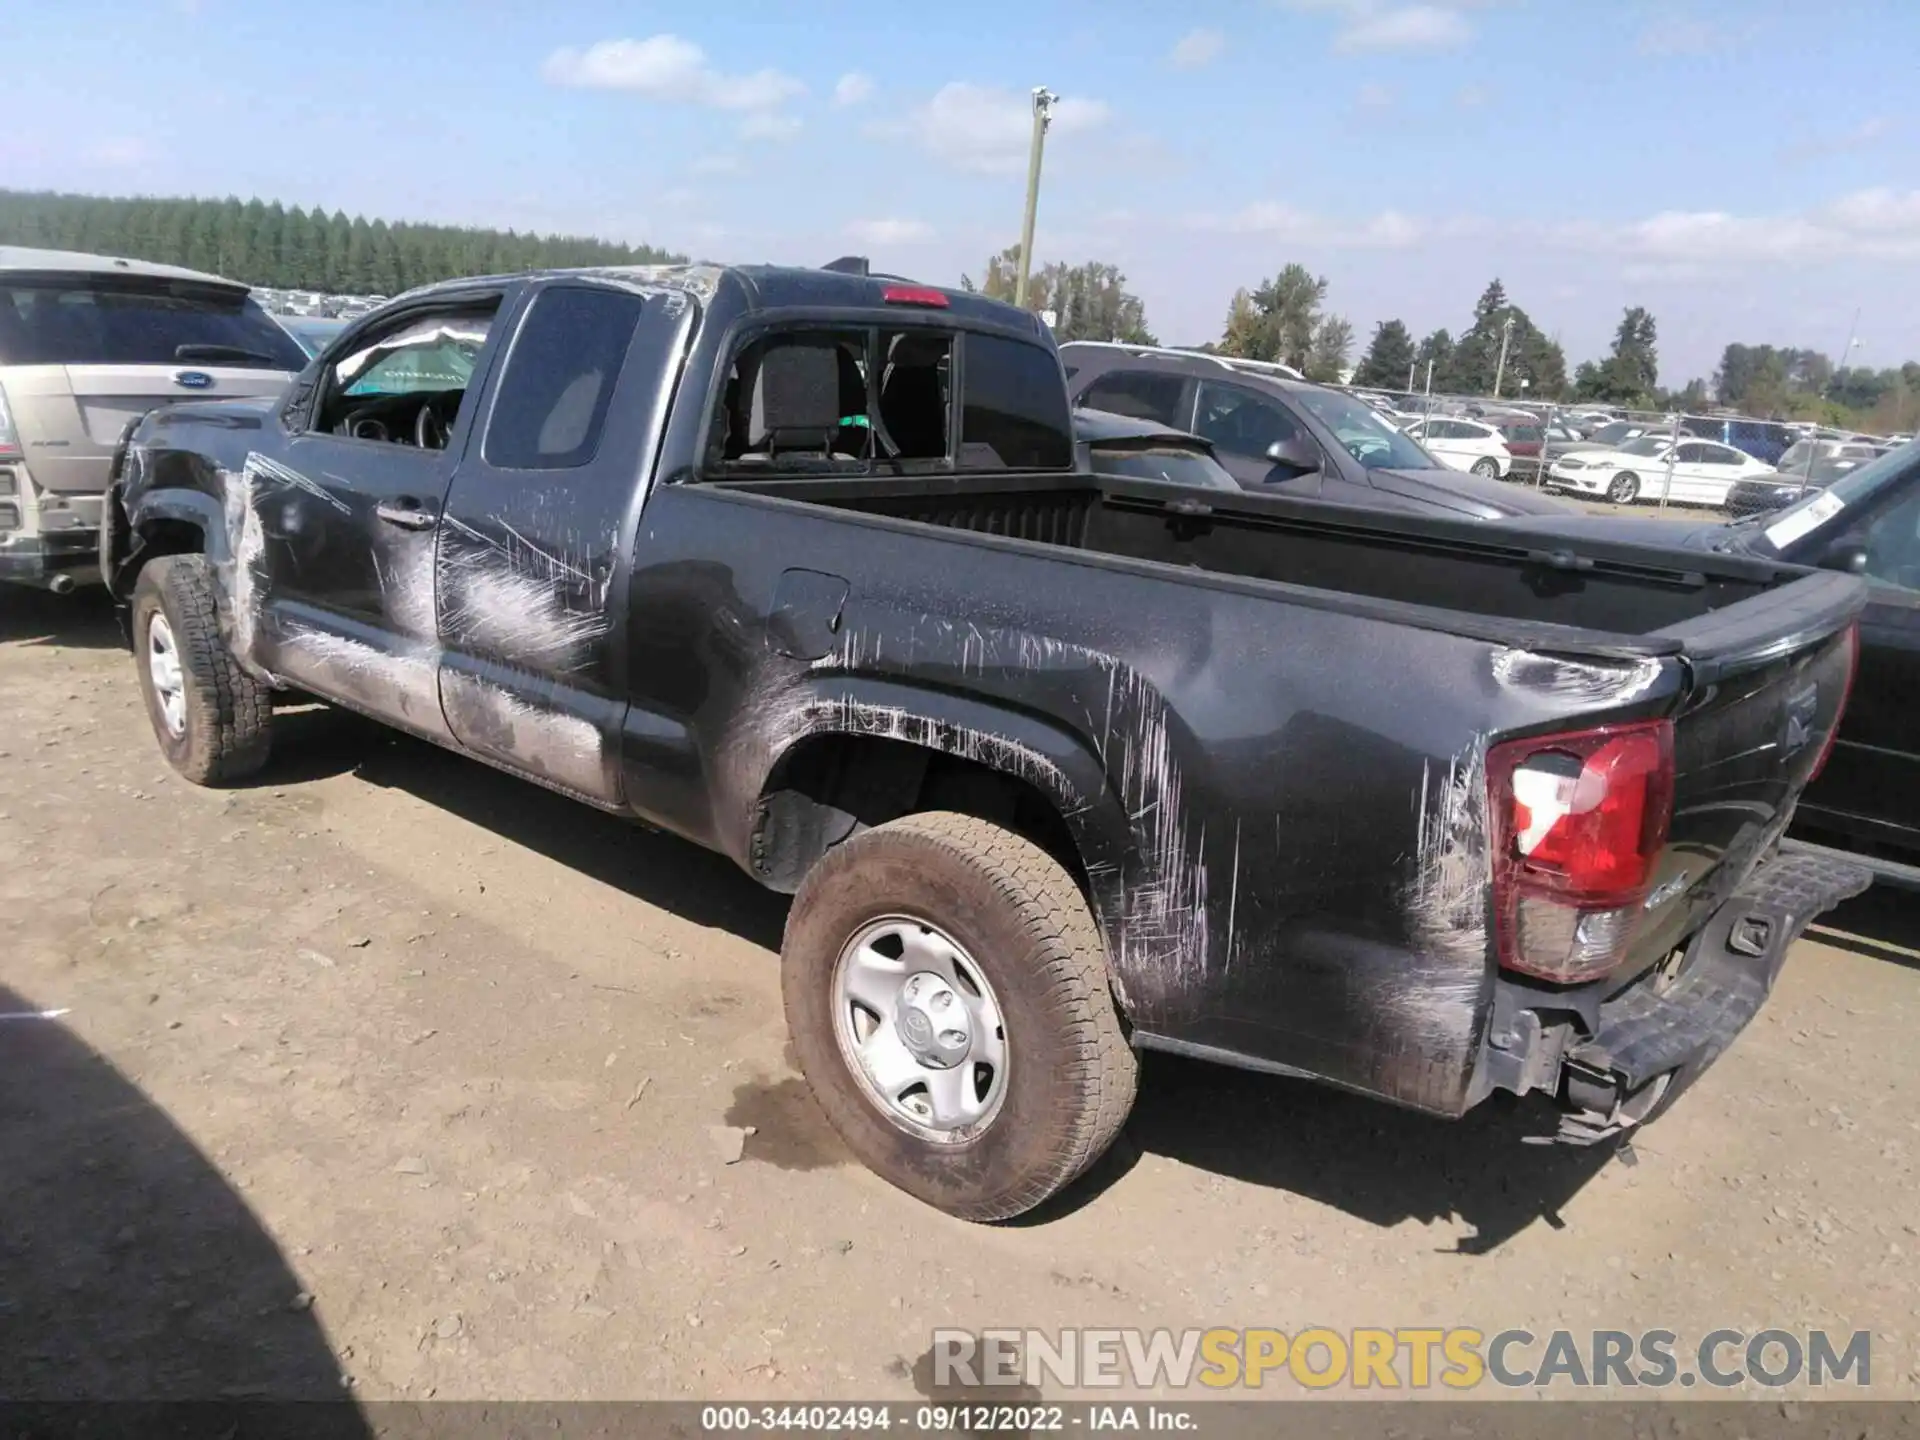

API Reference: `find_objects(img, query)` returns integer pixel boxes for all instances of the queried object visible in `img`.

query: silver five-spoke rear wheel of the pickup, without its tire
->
[831,916,1008,1144]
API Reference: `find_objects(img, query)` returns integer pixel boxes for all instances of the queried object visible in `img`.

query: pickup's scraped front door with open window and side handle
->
[253,294,501,739]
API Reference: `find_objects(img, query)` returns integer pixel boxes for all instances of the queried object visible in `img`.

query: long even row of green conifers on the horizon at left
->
[0,190,685,296]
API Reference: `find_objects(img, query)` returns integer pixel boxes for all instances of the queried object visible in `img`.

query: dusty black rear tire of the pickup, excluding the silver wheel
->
[781,812,1139,1221]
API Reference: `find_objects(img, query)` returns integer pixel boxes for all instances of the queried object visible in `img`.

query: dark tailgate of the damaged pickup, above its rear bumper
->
[1620,572,1866,979]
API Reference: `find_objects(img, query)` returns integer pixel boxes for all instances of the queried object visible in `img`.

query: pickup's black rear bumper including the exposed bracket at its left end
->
[1490,851,1872,1144]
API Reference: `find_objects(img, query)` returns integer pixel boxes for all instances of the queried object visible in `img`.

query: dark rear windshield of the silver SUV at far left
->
[0,276,307,371]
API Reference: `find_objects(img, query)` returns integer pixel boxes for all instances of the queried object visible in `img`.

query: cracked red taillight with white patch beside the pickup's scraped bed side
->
[1486,720,1674,983]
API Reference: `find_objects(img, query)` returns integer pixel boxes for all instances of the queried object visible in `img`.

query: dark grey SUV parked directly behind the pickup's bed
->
[1060,340,1571,520]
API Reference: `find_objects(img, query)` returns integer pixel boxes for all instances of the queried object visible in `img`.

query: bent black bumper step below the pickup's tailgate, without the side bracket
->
[1542,852,1872,1144]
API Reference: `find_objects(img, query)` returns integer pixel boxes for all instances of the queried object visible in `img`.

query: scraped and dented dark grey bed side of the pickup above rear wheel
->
[626,486,1680,1114]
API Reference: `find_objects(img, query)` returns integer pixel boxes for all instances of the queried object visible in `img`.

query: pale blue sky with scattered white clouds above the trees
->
[0,0,1920,384]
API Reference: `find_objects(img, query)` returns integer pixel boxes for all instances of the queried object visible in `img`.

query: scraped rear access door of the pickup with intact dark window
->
[436,280,693,806]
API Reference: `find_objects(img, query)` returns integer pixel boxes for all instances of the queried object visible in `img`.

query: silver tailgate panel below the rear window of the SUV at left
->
[6,361,292,495]
